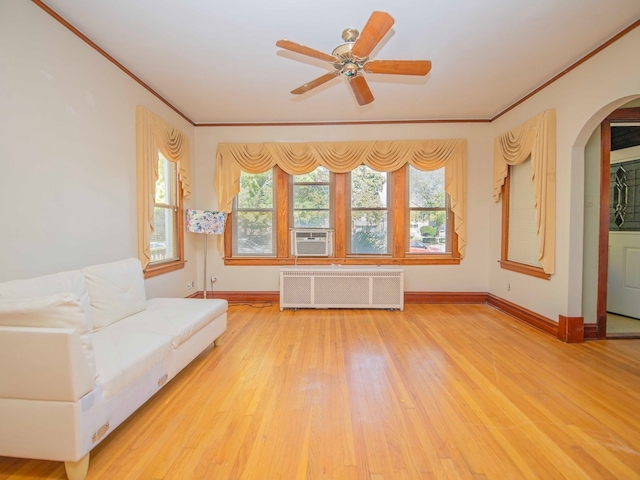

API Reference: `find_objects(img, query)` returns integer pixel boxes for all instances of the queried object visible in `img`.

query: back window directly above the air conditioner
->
[291,167,332,228]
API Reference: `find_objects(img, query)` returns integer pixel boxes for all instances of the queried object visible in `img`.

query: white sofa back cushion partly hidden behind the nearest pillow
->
[0,270,92,328]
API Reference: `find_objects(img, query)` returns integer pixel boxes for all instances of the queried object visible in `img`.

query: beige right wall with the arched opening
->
[489,25,640,320]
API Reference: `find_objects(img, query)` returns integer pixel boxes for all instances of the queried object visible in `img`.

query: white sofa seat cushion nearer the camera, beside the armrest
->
[92,327,171,399]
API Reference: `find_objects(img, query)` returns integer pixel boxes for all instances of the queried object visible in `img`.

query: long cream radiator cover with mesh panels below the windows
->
[280,266,404,310]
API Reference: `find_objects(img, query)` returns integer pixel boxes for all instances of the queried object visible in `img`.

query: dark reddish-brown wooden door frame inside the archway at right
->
[596,107,640,340]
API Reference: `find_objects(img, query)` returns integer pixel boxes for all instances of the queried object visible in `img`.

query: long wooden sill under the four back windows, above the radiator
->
[224,254,460,266]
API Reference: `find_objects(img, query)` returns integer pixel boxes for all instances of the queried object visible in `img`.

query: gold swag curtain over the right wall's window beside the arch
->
[493,110,556,275]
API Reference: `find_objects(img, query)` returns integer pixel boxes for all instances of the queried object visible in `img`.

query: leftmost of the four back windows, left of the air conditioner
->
[232,170,277,256]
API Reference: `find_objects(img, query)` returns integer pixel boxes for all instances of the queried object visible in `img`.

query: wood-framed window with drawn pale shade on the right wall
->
[500,156,549,278]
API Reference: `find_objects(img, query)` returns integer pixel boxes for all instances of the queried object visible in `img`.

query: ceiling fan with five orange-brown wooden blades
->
[276,12,431,105]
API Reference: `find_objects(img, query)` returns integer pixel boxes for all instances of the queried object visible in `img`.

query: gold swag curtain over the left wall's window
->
[136,106,191,269]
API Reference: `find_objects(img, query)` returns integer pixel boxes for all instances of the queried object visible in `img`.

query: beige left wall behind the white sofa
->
[0,1,196,296]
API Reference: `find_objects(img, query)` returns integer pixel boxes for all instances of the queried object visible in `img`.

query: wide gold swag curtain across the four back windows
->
[214,140,467,257]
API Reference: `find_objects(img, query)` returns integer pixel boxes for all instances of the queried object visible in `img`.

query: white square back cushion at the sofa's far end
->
[82,258,146,330]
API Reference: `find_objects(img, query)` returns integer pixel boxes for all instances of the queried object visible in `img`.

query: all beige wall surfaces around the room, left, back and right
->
[0,2,640,319]
